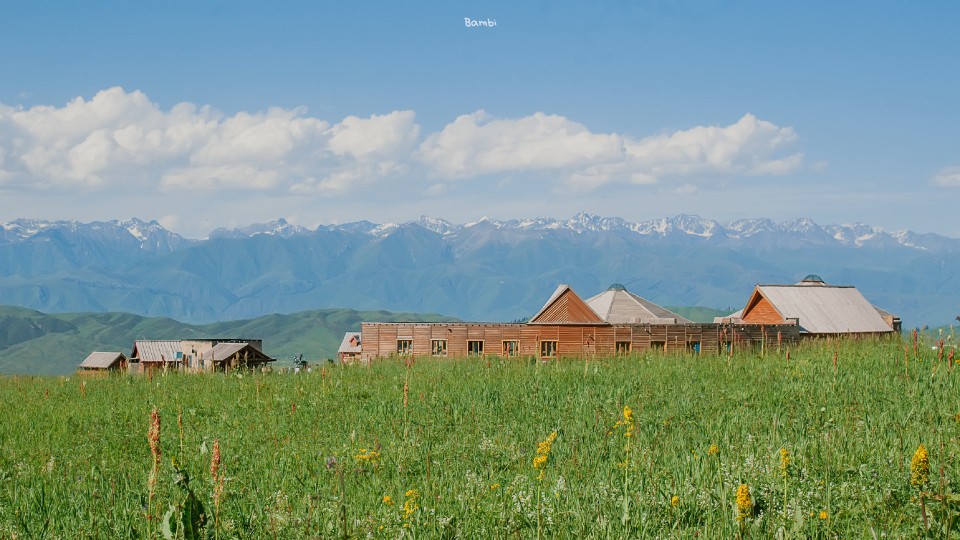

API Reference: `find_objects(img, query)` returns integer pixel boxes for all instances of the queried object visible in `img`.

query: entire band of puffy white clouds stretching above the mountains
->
[0,87,808,195]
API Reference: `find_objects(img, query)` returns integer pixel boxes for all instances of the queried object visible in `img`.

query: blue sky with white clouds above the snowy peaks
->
[0,0,960,238]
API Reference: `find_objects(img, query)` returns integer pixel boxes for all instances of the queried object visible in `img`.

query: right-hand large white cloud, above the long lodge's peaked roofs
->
[419,110,803,190]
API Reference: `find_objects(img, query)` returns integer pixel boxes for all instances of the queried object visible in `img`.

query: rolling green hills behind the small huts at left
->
[0,306,455,375]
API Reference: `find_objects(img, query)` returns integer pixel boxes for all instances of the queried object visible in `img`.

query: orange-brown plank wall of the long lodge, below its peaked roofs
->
[361,322,800,362]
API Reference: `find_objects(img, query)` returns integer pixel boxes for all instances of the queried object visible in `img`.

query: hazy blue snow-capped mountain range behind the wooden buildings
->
[0,213,960,328]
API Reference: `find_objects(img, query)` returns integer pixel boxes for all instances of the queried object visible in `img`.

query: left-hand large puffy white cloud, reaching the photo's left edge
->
[0,87,419,196]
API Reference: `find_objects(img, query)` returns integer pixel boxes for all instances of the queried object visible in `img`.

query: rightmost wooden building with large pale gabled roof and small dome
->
[717,274,901,337]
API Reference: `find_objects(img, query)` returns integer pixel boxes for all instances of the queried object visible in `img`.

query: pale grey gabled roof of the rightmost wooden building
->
[743,284,893,334]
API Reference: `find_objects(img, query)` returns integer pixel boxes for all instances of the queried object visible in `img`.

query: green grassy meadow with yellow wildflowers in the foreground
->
[0,338,960,538]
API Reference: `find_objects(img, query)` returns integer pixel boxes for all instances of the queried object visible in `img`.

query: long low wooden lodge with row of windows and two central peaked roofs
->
[360,285,800,362]
